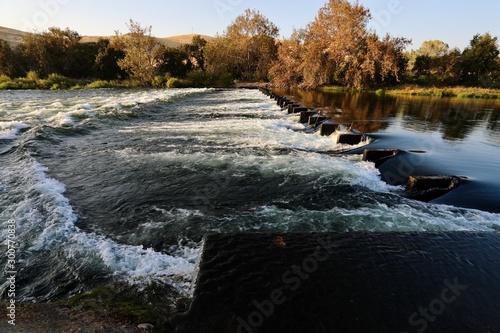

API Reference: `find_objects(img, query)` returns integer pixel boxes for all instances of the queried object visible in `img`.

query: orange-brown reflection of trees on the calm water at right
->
[278,90,500,140]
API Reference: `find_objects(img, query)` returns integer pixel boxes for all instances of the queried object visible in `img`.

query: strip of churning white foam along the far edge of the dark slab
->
[250,200,500,232]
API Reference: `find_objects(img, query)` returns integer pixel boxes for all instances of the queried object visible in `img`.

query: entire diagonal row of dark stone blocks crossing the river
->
[261,88,462,201]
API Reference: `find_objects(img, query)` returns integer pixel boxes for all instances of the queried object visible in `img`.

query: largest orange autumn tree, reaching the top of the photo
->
[270,0,410,89]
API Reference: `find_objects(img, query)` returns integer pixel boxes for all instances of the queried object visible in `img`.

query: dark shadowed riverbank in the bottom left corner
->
[0,283,189,333]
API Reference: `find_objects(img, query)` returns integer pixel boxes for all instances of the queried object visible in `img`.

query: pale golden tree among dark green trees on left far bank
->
[112,19,161,86]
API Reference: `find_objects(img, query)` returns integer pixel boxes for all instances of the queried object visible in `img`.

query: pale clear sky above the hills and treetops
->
[0,0,500,50]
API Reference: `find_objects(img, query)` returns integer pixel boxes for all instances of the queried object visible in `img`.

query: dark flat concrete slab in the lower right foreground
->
[171,232,500,333]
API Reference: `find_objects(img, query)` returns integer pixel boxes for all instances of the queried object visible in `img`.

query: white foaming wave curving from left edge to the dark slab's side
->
[0,159,198,291]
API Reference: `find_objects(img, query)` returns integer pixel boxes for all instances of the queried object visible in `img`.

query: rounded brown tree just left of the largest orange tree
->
[205,9,279,80]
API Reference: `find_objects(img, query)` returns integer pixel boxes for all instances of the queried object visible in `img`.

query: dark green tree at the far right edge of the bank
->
[462,33,500,86]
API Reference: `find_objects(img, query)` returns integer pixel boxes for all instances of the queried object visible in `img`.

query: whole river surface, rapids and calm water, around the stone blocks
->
[0,89,500,301]
